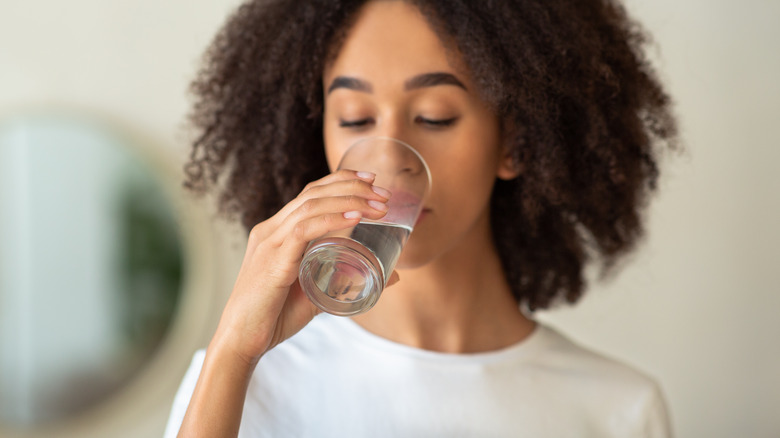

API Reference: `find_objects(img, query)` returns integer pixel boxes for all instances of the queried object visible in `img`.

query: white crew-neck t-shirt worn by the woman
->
[165,314,671,438]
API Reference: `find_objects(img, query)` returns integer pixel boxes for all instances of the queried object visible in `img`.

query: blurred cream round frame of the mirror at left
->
[0,108,225,438]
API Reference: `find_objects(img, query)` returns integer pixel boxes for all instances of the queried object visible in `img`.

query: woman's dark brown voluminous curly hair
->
[185,0,676,310]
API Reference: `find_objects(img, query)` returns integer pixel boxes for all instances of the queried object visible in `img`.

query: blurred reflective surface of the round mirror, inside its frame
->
[0,116,182,427]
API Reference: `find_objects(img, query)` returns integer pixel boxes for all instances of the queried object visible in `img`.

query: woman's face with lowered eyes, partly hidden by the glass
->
[323,1,514,269]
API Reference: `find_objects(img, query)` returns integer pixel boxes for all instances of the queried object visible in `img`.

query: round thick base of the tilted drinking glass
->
[299,237,385,316]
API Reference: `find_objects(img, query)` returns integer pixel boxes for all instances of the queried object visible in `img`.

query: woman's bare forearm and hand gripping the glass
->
[179,170,397,437]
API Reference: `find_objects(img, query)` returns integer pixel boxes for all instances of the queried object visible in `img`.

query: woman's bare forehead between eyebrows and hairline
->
[323,0,466,87]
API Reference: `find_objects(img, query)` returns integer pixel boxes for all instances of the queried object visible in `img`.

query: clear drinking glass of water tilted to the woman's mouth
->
[299,137,431,316]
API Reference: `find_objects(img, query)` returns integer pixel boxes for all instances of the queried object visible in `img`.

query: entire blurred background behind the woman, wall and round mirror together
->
[0,0,780,438]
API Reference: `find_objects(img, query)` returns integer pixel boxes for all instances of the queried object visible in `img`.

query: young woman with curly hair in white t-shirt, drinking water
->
[166,0,674,438]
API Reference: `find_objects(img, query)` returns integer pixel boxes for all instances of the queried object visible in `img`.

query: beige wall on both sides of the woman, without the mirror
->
[0,0,780,438]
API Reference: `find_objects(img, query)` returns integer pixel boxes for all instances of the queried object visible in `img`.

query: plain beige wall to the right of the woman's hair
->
[551,0,780,437]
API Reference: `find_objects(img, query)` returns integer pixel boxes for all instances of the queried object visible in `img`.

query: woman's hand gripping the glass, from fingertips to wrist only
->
[212,170,390,365]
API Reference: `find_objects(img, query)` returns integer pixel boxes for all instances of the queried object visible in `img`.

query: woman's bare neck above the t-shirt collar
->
[353,211,534,353]
